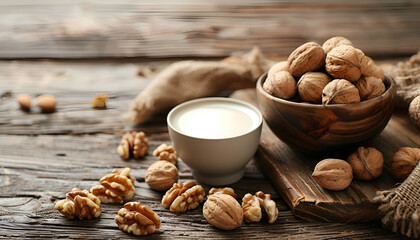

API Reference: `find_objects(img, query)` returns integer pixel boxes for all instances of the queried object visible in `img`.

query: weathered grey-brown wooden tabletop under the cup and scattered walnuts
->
[0,61,410,239]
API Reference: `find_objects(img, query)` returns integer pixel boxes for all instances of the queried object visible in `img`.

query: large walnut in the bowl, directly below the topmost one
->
[325,45,365,82]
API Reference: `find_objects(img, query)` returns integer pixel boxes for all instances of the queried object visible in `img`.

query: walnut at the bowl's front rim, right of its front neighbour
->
[322,79,360,105]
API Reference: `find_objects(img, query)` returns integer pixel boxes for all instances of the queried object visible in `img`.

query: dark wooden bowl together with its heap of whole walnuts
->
[257,37,396,151]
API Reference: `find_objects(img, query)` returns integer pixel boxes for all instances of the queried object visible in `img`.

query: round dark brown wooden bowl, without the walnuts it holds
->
[257,73,396,151]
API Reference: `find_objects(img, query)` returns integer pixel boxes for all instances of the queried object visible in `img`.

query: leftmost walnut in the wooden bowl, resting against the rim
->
[263,71,296,99]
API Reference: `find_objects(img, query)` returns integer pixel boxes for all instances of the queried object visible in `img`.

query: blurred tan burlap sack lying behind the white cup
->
[127,48,273,124]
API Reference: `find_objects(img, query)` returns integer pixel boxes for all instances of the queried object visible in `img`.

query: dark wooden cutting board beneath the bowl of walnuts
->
[232,89,420,222]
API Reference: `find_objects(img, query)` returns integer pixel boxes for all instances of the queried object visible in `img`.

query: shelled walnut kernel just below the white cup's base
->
[162,180,206,212]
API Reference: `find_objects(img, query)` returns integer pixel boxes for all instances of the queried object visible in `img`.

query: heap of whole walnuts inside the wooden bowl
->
[263,36,386,105]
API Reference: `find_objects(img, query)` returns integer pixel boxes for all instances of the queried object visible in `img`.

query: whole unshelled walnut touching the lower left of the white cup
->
[145,161,179,191]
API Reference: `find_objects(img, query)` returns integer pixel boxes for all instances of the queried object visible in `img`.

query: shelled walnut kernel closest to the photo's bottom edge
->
[115,202,161,235]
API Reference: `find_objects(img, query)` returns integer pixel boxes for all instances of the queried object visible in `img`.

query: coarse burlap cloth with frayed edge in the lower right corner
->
[374,164,420,238]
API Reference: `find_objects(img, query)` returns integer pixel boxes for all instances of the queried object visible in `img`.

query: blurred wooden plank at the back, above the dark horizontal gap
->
[0,0,420,59]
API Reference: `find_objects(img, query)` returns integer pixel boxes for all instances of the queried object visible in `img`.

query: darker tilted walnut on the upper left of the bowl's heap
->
[287,42,325,77]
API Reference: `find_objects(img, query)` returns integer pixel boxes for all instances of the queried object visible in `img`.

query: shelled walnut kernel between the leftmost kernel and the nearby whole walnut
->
[90,168,136,203]
